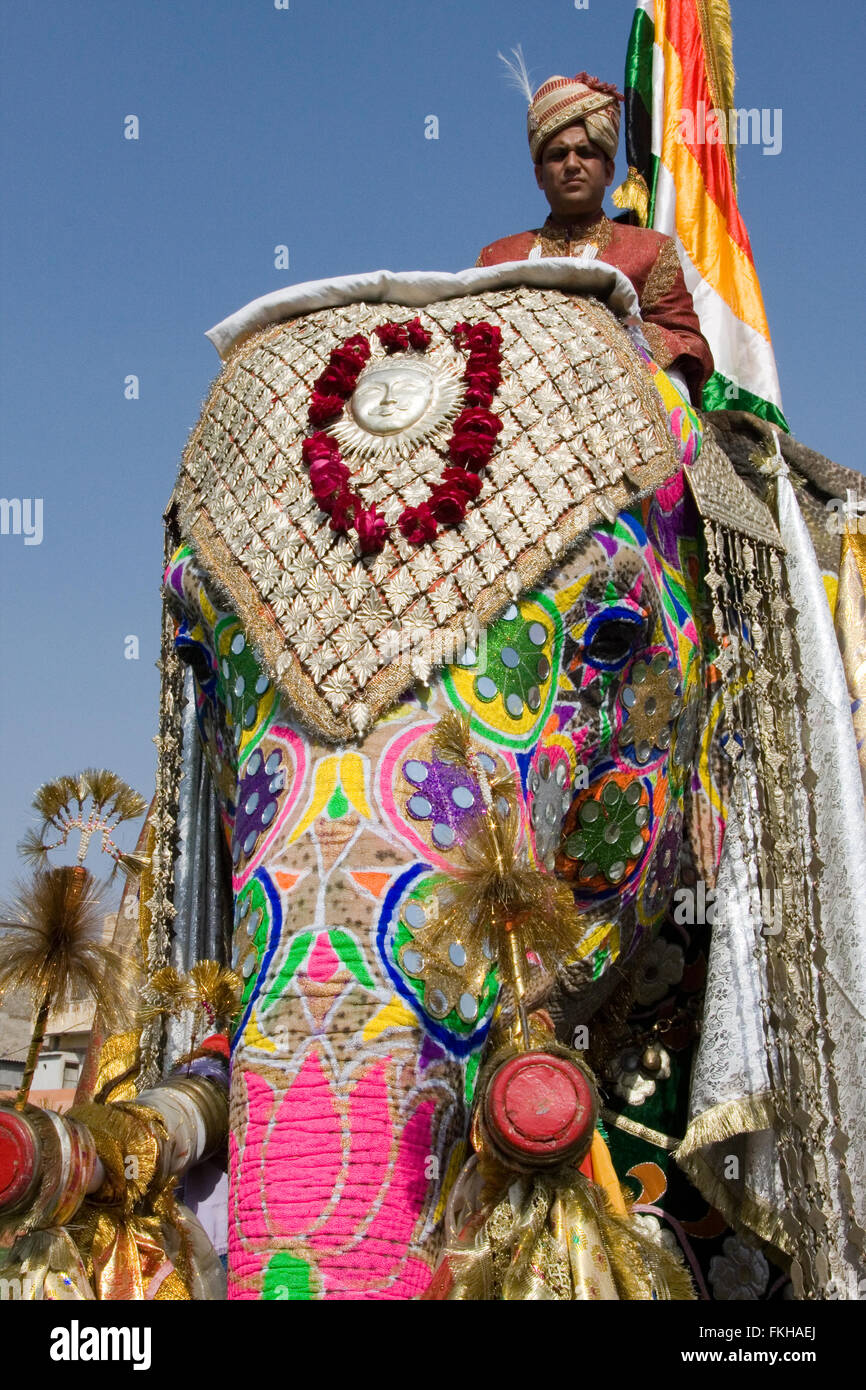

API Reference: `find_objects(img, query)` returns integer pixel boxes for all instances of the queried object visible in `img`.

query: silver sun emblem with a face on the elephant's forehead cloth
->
[331,353,460,457]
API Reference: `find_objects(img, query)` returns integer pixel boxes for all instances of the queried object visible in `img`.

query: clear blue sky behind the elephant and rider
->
[0,0,866,895]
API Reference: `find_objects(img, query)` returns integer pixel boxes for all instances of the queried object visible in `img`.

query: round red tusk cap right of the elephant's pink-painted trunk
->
[484,1052,596,1168]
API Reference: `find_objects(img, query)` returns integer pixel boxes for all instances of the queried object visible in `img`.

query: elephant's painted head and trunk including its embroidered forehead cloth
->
[159,272,705,1298]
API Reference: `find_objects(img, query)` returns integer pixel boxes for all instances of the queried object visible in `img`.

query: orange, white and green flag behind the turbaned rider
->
[614,0,788,430]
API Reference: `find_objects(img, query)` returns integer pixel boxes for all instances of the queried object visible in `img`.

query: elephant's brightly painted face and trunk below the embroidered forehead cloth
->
[165,480,702,1298]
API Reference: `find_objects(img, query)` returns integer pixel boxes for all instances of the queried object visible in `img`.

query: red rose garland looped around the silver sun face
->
[302,318,502,555]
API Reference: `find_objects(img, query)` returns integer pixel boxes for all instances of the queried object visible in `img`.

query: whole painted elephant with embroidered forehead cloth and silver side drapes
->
[127,260,866,1300]
